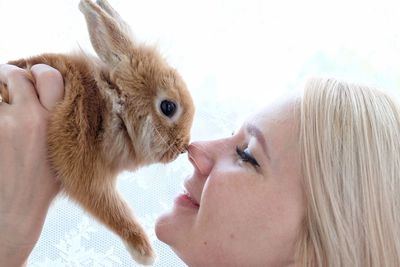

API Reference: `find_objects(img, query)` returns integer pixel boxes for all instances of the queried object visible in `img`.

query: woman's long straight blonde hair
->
[298,79,400,267]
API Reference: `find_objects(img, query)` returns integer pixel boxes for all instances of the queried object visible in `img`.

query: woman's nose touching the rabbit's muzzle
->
[188,142,214,176]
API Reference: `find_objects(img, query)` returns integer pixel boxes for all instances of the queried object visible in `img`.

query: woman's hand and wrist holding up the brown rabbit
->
[0,64,64,267]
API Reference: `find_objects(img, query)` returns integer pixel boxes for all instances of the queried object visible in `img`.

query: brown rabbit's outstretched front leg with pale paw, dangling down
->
[65,185,155,265]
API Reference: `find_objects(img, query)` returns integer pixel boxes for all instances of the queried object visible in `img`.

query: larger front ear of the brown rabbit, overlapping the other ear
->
[79,0,134,66]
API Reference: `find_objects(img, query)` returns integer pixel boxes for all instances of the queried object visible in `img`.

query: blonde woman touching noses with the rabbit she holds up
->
[0,63,400,266]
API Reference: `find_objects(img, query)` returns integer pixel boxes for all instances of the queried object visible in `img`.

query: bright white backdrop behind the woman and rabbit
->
[0,0,400,267]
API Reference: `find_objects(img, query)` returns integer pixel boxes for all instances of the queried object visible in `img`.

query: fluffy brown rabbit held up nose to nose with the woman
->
[0,0,194,264]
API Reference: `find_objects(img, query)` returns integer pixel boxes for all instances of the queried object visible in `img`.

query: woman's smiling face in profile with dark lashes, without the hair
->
[156,98,305,266]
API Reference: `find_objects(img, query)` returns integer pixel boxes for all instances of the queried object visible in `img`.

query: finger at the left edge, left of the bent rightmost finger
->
[0,64,38,104]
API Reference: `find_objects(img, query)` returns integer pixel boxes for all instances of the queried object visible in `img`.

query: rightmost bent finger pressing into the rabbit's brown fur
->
[31,64,64,111]
